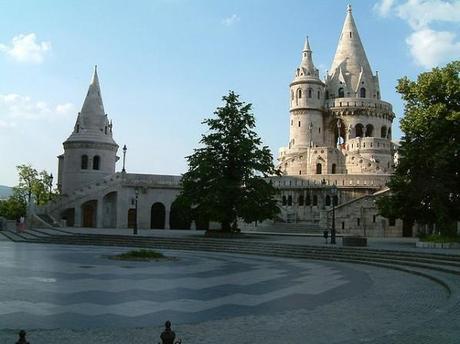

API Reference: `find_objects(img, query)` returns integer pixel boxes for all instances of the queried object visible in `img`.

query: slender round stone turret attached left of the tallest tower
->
[288,37,325,150]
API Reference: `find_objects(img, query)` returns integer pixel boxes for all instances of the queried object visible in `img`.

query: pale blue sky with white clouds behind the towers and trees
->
[0,0,460,186]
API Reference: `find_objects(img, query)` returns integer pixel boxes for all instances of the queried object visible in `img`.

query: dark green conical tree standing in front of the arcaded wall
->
[180,91,279,231]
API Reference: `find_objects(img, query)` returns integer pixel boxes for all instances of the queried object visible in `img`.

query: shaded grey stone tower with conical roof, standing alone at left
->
[58,67,118,194]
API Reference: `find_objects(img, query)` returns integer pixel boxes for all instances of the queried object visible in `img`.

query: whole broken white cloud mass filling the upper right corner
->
[374,0,460,69]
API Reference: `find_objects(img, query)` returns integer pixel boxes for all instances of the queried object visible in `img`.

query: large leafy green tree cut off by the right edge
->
[378,61,460,234]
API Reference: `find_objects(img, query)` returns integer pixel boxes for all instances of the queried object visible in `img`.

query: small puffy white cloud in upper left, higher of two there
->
[0,33,51,64]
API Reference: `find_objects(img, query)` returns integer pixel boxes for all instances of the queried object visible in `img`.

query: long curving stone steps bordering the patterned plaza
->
[5,229,460,293]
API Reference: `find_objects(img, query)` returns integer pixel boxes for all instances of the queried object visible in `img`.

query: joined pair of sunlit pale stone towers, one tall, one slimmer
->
[279,6,394,175]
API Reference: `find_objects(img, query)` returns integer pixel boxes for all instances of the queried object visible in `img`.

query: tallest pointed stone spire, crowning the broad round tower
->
[329,5,372,89]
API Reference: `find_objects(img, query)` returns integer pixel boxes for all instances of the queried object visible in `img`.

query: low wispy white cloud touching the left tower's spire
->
[0,93,75,128]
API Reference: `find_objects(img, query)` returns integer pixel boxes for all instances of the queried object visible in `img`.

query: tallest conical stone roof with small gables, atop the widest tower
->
[329,5,378,97]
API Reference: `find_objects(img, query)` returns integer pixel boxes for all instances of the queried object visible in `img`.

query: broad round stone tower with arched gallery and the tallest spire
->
[325,5,394,174]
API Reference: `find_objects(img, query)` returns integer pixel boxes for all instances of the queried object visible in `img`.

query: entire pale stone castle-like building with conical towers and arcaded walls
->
[38,7,406,237]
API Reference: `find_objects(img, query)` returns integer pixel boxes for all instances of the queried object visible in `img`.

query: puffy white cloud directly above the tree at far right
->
[406,29,460,68]
